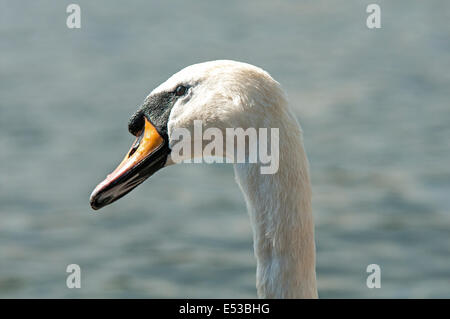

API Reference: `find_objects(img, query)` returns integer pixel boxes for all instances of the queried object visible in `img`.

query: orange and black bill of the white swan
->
[90,117,170,210]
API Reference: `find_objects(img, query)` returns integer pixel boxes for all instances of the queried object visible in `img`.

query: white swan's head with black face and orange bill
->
[90,60,286,209]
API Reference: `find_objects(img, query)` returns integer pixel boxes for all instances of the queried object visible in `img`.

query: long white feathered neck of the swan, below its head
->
[235,124,317,298]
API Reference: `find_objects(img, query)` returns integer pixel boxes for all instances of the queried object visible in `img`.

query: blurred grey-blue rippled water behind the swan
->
[0,0,450,298]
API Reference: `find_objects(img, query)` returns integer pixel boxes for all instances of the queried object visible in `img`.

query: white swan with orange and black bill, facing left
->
[90,60,318,298]
